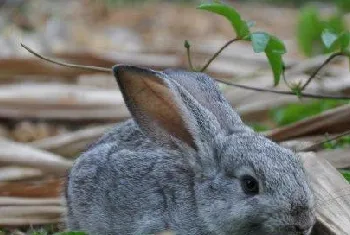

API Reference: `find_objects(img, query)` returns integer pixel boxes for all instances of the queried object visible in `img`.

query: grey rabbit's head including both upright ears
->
[113,65,315,235]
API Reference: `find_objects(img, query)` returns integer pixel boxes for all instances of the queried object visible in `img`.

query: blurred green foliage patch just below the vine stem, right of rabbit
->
[271,99,349,126]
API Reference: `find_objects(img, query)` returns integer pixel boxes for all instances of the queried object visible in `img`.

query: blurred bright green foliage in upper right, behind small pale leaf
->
[297,6,346,57]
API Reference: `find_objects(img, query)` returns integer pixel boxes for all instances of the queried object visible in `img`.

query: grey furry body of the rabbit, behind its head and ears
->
[67,120,204,235]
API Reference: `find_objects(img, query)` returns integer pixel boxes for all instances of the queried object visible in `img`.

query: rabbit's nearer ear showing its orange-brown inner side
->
[113,65,196,149]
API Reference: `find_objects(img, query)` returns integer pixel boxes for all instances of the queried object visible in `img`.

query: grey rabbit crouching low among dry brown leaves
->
[66,65,316,235]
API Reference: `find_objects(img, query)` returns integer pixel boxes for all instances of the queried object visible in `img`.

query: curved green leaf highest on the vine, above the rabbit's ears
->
[198,2,250,39]
